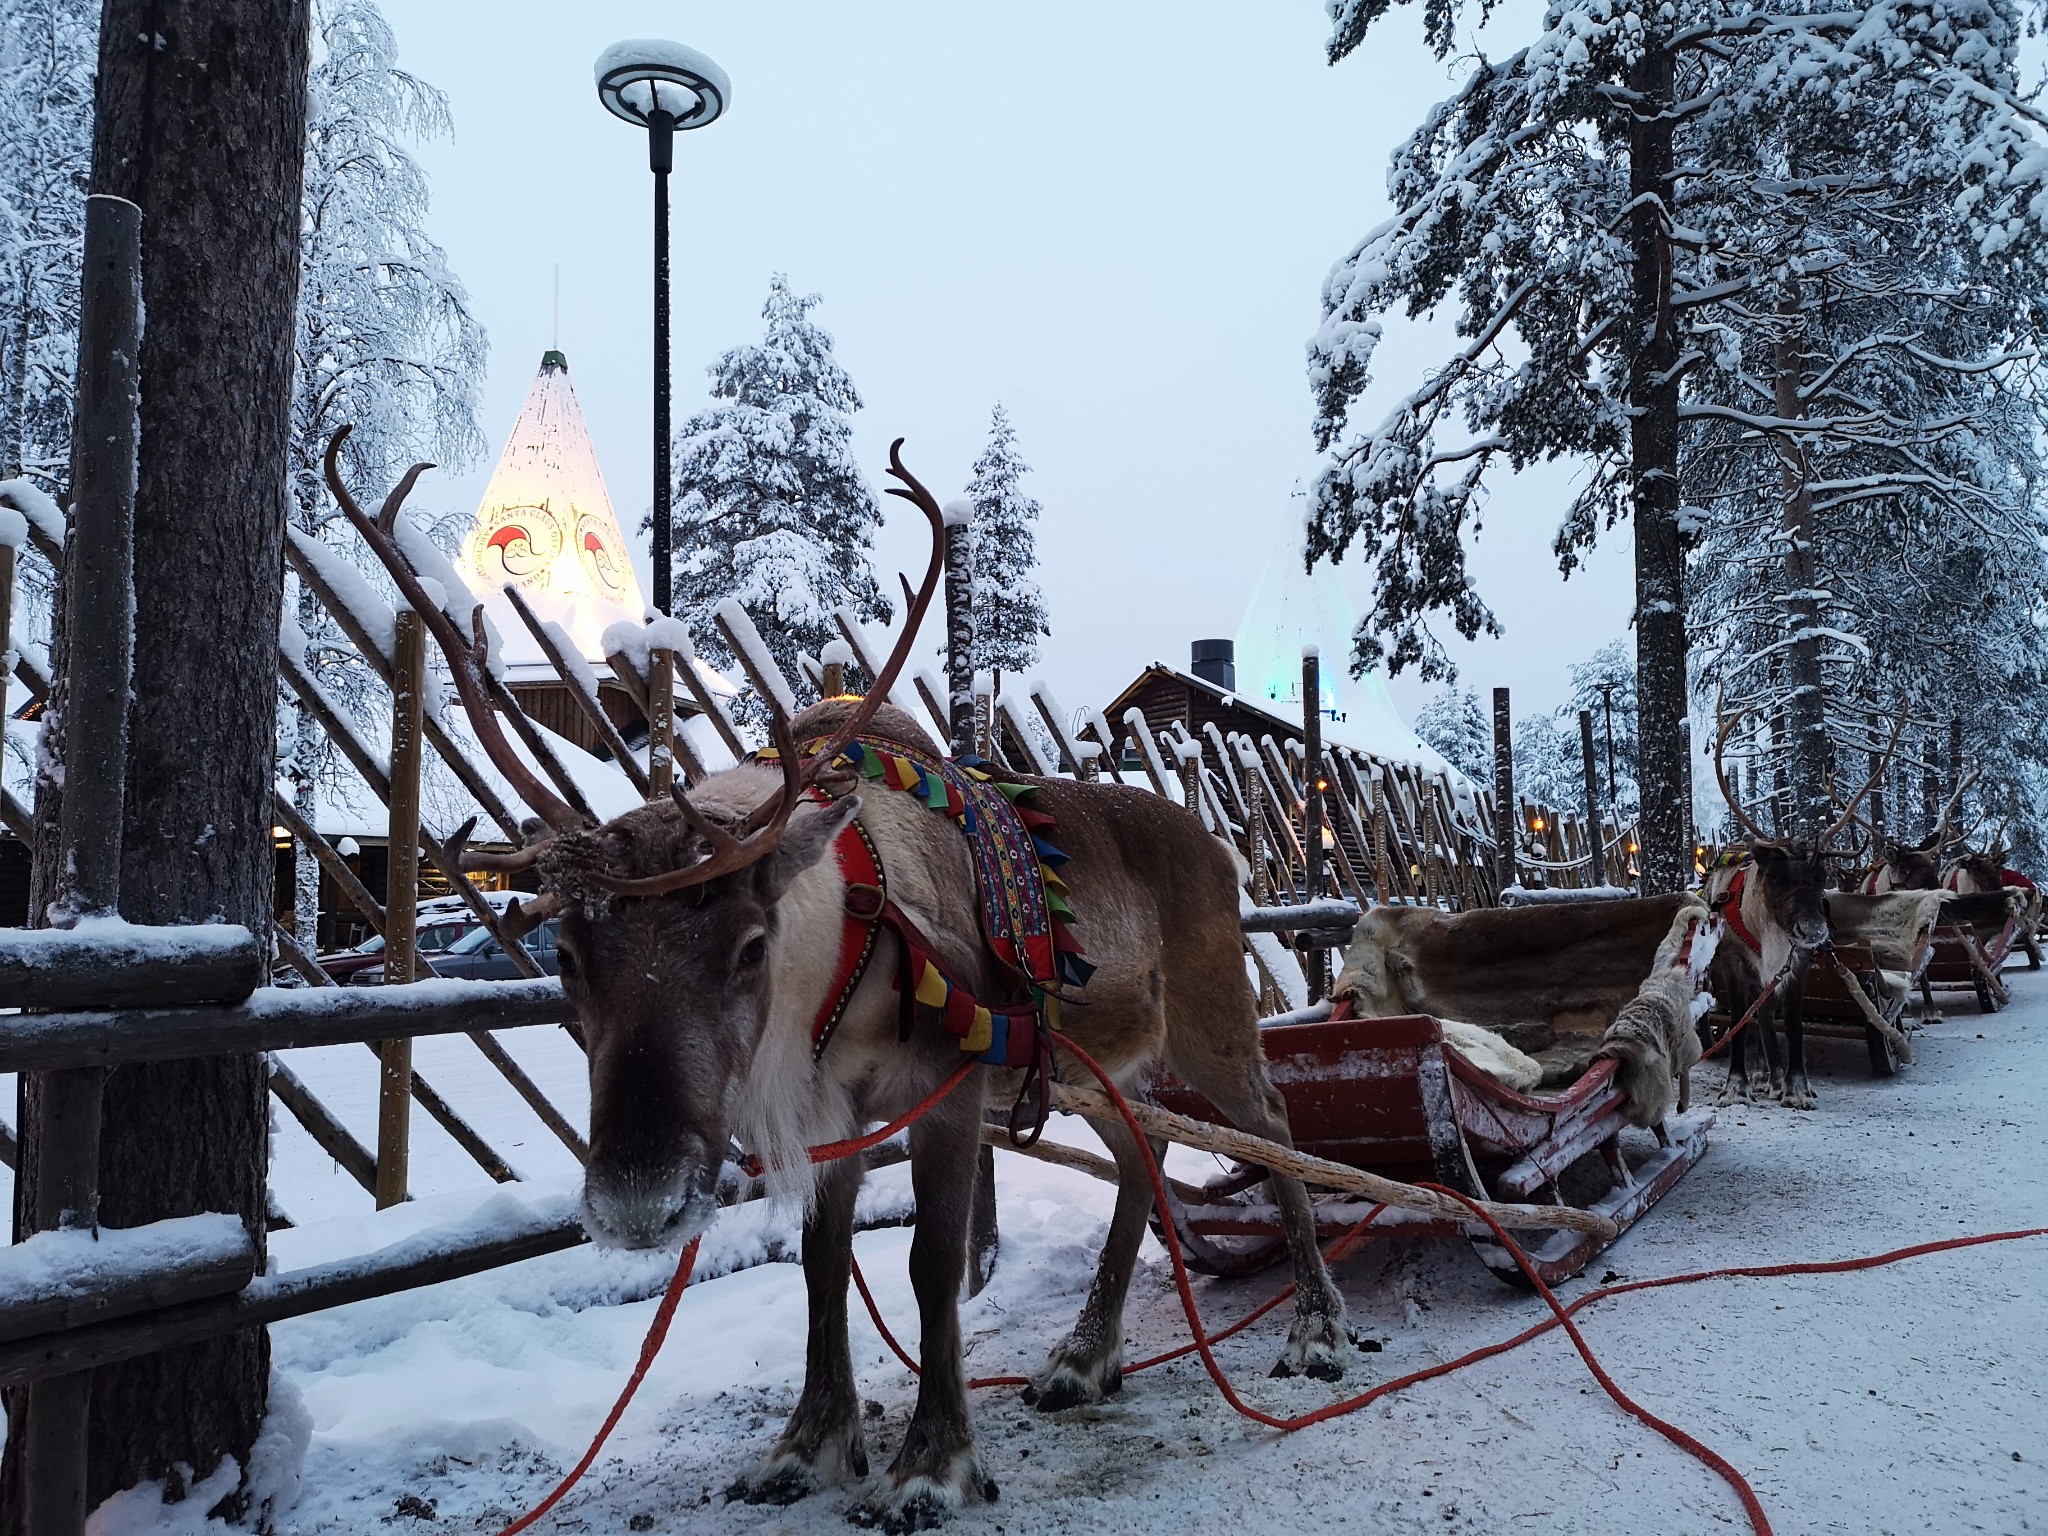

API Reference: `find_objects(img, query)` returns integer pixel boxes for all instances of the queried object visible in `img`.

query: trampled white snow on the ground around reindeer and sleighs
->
[24,973,2048,1536]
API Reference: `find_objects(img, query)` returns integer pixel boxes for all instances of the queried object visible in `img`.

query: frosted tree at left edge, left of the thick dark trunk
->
[0,0,100,494]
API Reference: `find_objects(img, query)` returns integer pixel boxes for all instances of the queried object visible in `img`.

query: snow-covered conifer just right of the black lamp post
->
[674,272,891,711]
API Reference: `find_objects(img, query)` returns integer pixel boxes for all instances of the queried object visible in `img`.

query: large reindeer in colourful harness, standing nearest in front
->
[328,436,1348,1530]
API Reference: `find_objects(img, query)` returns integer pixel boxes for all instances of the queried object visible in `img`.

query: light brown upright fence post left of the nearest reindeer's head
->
[377,608,426,1210]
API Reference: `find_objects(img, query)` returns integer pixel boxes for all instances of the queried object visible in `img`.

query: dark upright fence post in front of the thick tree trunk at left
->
[22,197,141,1536]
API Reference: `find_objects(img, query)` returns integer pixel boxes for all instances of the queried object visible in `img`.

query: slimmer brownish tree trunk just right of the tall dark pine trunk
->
[1772,309,1833,836]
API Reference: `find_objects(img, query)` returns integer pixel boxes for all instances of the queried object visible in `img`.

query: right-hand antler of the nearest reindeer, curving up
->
[592,438,946,897]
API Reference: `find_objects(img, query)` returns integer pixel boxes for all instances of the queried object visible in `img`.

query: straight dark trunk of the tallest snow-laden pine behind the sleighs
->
[1628,43,1692,895]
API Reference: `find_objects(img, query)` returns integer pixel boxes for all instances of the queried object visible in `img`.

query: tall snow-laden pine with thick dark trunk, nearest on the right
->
[1309,0,2048,891]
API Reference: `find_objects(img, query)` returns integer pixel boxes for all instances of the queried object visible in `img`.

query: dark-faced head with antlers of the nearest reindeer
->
[328,428,944,1247]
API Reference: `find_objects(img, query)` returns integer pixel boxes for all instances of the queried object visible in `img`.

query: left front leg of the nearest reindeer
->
[725,1157,868,1503]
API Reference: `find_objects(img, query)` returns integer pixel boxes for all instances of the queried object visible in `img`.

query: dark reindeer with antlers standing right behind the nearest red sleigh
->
[1702,705,1905,1110]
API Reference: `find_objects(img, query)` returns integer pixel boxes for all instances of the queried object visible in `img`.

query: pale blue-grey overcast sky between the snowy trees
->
[383,0,1632,729]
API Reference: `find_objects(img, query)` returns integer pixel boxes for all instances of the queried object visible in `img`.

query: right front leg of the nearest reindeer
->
[848,1094,995,1532]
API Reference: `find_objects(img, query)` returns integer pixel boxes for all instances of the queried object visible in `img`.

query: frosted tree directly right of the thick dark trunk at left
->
[279,0,487,936]
